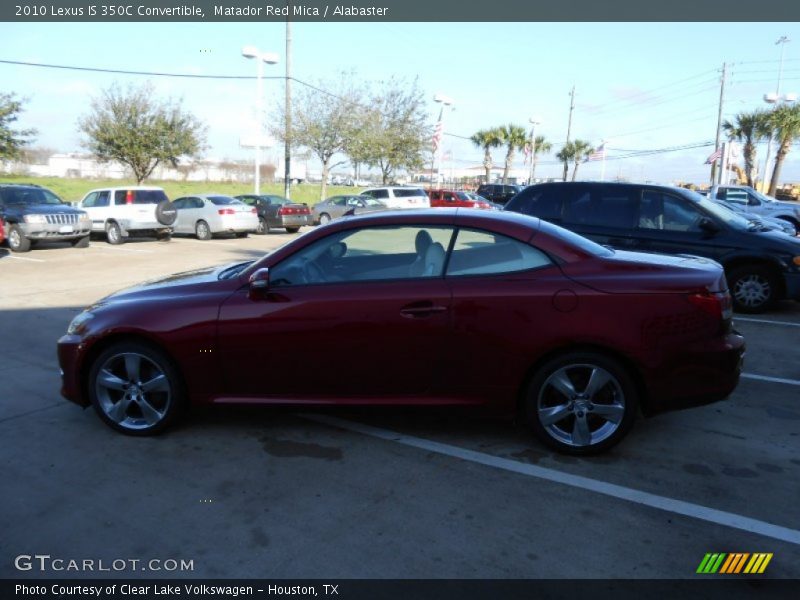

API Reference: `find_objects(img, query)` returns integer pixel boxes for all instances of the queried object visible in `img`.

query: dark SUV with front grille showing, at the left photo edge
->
[0,184,92,252]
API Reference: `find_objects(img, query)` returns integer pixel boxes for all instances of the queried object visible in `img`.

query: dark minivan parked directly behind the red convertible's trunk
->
[505,182,800,313]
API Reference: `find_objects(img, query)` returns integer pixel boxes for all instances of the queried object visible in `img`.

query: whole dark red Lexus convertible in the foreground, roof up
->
[58,209,744,454]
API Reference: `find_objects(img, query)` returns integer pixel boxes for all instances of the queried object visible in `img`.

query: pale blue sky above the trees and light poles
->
[0,23,800,183]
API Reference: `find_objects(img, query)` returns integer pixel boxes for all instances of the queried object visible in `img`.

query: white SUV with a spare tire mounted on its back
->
[78,186,178,244]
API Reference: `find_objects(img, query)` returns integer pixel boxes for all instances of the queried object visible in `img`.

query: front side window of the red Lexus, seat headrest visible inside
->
[270,226,453,287]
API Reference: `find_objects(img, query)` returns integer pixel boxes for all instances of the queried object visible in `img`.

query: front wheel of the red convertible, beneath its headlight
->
[88,342,186,436]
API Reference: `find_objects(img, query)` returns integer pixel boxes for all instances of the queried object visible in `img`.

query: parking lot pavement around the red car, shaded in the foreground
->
[0,233,800,579]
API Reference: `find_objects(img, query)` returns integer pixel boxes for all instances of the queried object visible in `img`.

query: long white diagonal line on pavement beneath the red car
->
[299,414,800,546]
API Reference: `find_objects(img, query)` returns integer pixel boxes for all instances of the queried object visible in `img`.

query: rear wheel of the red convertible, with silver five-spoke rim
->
[523,352,639,456]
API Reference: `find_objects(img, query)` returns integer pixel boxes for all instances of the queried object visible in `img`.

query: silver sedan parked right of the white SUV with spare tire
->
[172,194,258,240]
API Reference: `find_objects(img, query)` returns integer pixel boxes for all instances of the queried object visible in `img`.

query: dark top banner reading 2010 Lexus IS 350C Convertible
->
[0,0,800,22]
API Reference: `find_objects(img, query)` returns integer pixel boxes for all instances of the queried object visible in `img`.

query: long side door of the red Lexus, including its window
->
[218,226,452,403]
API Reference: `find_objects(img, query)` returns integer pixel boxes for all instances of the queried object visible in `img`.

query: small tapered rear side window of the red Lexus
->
[447,229,552,277]
